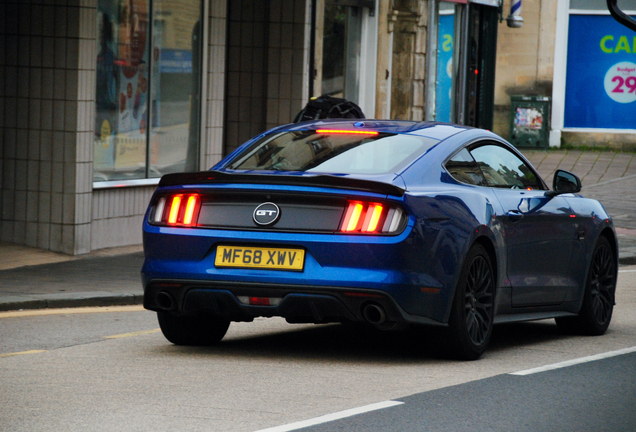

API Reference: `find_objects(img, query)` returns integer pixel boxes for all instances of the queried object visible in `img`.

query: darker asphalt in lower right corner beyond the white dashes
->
[294,353,636,432]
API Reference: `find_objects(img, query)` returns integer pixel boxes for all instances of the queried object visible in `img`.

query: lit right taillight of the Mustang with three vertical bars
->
[340,201,405,234]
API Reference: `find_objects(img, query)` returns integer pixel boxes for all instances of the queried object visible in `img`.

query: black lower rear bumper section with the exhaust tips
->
[144,279,445,325]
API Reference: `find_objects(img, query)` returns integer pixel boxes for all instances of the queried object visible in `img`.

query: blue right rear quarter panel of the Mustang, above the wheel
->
[401,129,509,322]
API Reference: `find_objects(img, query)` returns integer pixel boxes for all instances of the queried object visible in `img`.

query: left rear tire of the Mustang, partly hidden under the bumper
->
[157,311,230,346]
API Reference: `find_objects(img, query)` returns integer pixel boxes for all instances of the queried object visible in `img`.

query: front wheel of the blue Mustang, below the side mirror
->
[556,237,616,336]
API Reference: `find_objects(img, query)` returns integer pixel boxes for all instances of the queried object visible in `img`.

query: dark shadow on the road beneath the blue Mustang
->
[153,320,571,365]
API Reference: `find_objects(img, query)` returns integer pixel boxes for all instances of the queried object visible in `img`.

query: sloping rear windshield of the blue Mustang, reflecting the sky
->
[227,131,438,174]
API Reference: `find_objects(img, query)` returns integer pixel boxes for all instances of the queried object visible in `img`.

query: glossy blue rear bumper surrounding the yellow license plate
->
[142,218,456,325]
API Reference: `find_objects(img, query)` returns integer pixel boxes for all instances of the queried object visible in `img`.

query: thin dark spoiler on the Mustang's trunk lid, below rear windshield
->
[159,171,405,197]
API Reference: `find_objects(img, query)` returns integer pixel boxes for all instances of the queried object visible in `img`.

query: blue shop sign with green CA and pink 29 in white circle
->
[564,15,636,129]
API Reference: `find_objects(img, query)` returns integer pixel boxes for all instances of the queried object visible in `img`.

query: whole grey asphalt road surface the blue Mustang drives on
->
[0,267,636,432]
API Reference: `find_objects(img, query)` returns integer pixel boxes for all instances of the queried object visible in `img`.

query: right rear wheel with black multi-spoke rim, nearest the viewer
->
[447,245,496,360]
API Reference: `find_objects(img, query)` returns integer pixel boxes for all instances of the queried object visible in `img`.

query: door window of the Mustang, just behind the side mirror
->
[470,145,542,189]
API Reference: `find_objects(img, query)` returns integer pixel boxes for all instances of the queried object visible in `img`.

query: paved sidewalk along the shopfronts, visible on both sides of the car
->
[0,150,636,311]
